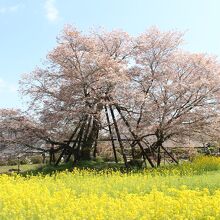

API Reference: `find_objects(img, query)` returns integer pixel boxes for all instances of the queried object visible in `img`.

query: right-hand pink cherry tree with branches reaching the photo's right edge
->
[124,29,220,164]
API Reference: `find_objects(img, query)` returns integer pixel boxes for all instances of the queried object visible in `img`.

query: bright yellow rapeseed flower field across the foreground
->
[0,157,220,219]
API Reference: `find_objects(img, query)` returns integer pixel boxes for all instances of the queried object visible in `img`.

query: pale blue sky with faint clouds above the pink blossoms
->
[0,0,220,108]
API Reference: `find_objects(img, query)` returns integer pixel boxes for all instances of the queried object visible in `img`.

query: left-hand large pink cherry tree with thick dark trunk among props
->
[22,26,131,159]
